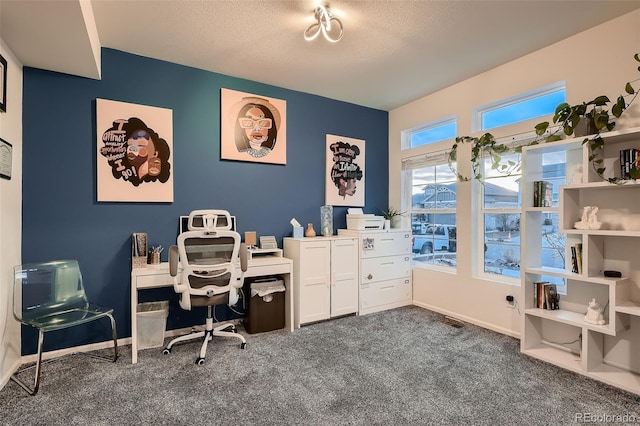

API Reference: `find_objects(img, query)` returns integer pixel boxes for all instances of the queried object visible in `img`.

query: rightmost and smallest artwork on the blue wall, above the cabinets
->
[325,135,365,207]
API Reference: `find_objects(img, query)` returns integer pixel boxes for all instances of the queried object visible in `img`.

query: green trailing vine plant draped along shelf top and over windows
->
[448,53,640,183]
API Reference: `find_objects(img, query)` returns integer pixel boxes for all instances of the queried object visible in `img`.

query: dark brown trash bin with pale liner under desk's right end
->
[244,277,286,334]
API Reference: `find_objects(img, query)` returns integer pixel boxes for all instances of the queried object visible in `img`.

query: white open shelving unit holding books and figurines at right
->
[521,128,640,394]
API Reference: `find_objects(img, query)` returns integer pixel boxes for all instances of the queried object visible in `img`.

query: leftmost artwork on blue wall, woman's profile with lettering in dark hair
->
[96,99,173,202]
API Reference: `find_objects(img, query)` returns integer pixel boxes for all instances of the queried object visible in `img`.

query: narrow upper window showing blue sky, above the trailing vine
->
[474,82,566,131]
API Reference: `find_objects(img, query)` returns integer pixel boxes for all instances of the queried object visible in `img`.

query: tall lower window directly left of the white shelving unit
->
[479,153,521,280]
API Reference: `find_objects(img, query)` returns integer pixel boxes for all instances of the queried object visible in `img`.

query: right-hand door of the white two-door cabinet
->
[331,238,358,317]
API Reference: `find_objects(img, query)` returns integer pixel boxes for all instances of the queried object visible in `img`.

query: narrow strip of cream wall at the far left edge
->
[0,39,22,389]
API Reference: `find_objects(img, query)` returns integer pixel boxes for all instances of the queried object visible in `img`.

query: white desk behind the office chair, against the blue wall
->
[131,256,293,364]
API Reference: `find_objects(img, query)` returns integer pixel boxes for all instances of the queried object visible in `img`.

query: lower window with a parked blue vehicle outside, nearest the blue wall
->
[403,153,457,267]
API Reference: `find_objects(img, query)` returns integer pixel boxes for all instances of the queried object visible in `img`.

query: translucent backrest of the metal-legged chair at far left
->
[13,260,89,323]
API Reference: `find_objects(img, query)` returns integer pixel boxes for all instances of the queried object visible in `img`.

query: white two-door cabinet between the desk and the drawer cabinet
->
[284,237,358,327]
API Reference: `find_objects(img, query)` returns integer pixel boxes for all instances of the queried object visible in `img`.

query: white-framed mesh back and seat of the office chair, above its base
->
[169,210,246,310]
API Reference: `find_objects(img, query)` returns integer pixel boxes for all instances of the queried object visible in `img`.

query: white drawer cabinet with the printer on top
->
[338,229,413,315]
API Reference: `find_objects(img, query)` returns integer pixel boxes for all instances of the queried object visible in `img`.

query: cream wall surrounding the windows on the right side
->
[389,10,640,336]
